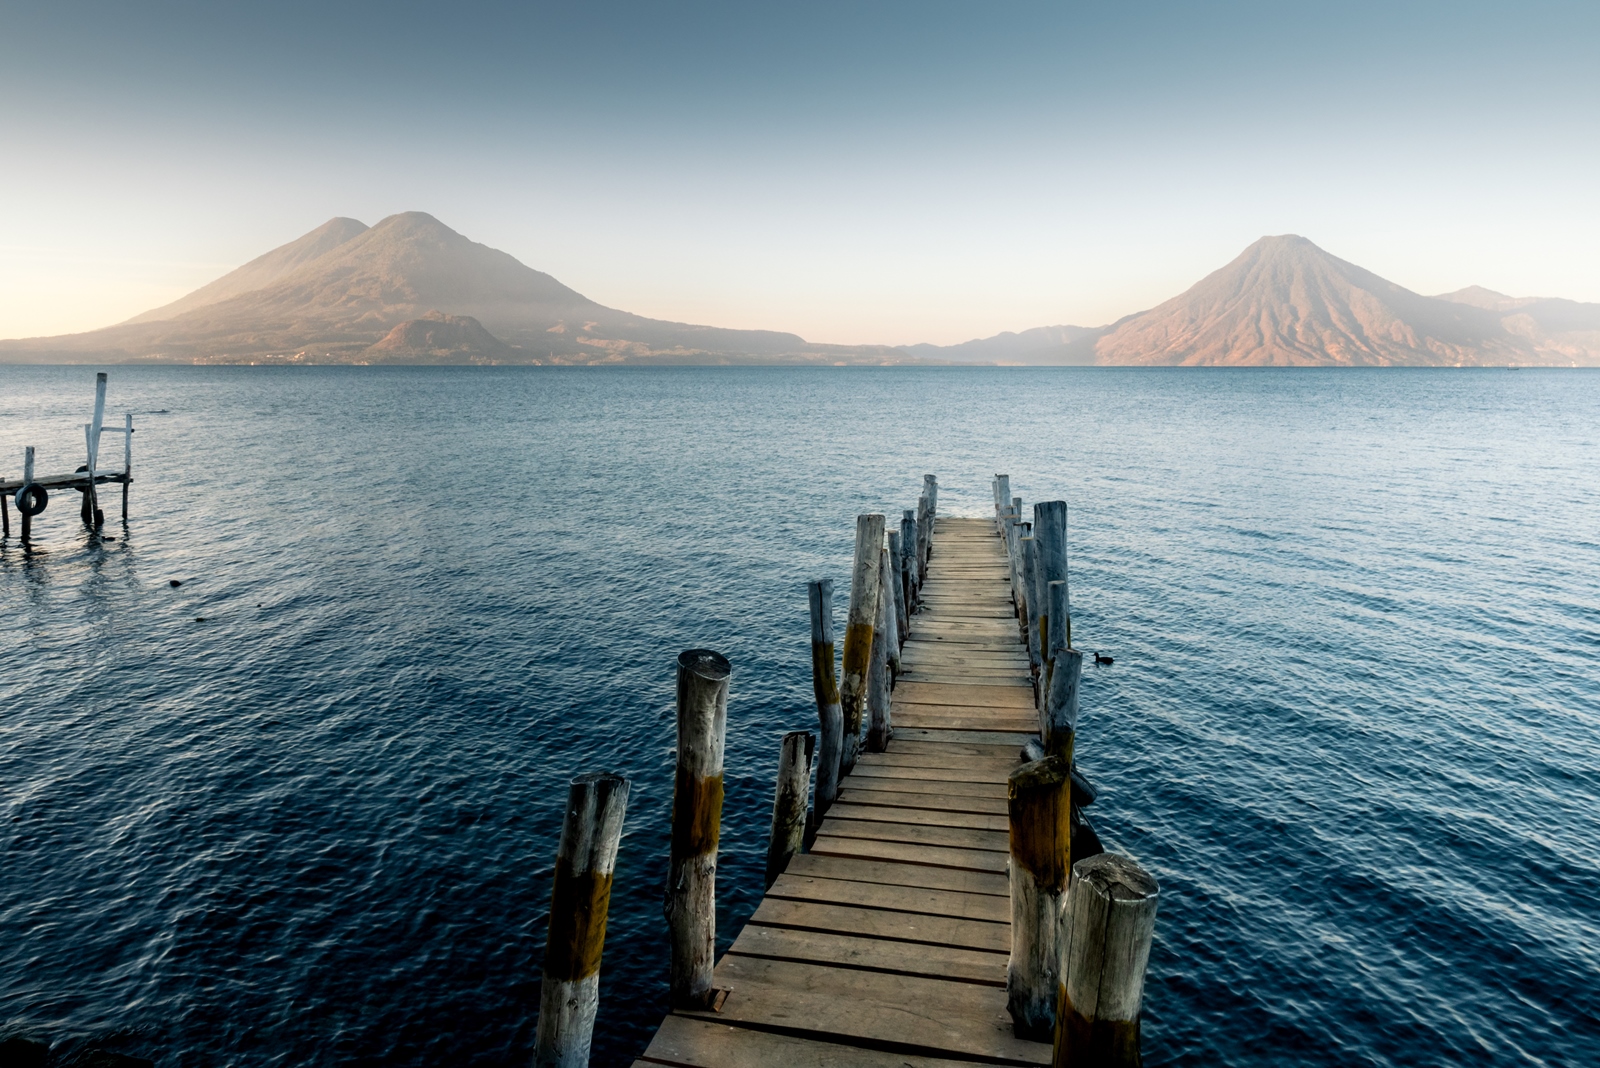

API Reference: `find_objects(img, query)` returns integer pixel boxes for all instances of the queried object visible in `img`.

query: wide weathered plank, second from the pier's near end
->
[684,954,1050,1065]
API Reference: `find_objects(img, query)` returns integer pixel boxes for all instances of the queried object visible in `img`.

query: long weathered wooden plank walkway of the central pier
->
[635,518,1050,1068]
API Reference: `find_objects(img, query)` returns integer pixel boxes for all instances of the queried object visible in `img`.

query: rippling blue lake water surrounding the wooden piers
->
[0,368,1600,1068]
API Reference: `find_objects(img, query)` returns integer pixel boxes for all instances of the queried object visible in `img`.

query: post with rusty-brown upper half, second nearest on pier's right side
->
[1005,758,1072,1041]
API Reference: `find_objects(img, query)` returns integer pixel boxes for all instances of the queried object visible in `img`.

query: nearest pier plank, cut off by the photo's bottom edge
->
[634,1017,971,1068]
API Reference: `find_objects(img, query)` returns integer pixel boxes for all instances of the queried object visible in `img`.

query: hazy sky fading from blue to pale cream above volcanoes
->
[0,0,1600,344]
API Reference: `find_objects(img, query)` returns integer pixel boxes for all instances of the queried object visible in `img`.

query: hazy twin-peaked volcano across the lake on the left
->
[0,211,912,363]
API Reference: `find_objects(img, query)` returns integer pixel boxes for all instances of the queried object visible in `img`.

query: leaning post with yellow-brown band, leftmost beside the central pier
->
[533,774,629,1068]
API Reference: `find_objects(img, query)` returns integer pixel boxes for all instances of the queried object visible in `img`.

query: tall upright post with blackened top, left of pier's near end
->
[664,649,733,1009]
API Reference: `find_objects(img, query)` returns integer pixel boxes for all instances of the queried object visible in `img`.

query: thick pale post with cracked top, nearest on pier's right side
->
[1051,852,1160,1068]
